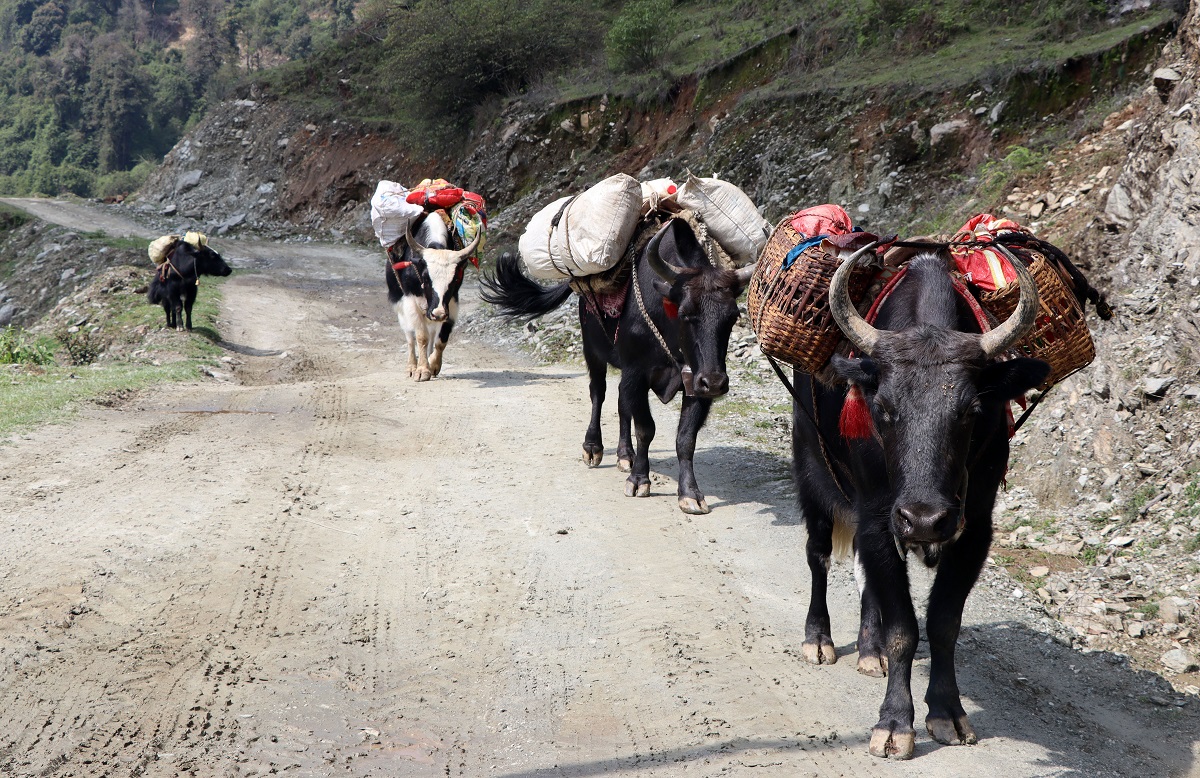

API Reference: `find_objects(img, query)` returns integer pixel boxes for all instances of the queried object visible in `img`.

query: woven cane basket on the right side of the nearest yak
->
[979,250,1096,391]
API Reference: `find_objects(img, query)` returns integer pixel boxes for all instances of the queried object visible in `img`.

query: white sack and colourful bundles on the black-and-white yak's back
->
[371,179,487,261]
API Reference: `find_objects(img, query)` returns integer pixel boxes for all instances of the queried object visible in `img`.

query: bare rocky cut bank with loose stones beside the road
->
[119,7,1200,690]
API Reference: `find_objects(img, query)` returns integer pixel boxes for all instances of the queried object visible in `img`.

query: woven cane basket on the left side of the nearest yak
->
[746,217,874,373]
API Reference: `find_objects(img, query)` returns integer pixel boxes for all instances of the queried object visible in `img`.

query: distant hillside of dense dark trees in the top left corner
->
[0,0,353,197]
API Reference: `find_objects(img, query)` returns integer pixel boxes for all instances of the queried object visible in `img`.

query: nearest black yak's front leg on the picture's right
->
[925,505,991,746]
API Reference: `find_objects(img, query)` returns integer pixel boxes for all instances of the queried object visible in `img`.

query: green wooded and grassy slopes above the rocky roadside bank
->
[0,0,1170,197]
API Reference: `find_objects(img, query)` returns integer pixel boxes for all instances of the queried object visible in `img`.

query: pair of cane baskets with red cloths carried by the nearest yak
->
[748,205,1111,390]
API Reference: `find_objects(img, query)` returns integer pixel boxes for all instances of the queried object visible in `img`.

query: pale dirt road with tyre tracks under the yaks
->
[0,201,1200,778]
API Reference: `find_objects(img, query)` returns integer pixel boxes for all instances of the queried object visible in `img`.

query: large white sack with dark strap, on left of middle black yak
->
[517,173,642,281]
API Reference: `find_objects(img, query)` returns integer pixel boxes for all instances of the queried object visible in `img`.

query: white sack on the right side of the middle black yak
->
[676,175,770,267]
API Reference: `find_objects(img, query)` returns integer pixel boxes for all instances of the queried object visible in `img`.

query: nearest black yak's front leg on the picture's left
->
[857,516,917,759]
